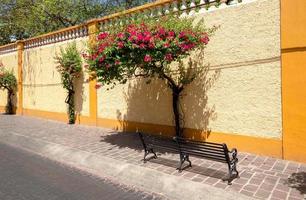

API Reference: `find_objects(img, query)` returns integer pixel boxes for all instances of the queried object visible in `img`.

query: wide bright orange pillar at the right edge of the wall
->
[281,0,306,162]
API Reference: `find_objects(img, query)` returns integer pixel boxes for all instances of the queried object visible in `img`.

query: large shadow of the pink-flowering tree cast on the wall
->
[103,51,220,148]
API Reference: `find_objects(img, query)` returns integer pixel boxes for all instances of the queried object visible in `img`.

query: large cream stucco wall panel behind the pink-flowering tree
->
[98,0,282,138]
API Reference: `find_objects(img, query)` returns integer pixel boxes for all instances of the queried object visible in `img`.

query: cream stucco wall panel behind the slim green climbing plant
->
[23,38,89,116]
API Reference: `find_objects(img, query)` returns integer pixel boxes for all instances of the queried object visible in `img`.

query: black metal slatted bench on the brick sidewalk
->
[138,132,239,184]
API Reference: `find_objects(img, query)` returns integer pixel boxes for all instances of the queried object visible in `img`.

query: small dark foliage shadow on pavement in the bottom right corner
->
[286,172,306,194]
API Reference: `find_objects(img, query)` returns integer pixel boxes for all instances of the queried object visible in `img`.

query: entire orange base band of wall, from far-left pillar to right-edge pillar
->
[18,107,282,158]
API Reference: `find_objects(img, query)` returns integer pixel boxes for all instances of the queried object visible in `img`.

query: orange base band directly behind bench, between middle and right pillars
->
[97,119,282,158]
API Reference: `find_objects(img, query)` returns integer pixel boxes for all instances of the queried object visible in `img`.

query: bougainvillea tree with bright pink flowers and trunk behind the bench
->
[83,16,214,136]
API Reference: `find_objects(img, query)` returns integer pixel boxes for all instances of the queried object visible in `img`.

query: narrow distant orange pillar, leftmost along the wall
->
[17,41,24,114]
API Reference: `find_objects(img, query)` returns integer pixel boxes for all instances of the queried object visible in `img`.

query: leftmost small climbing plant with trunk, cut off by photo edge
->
[0,62,17,114]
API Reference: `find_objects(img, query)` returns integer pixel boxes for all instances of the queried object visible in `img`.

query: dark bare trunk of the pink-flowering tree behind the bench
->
[172,87,183,137]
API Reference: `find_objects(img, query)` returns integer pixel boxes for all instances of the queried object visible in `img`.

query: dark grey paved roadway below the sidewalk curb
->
[0,143,162,200]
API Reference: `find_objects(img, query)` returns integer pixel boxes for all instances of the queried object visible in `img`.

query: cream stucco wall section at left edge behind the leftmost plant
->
[0,51,18,106]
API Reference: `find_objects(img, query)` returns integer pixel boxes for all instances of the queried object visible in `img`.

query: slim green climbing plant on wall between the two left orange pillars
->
[55,43,82,124]
